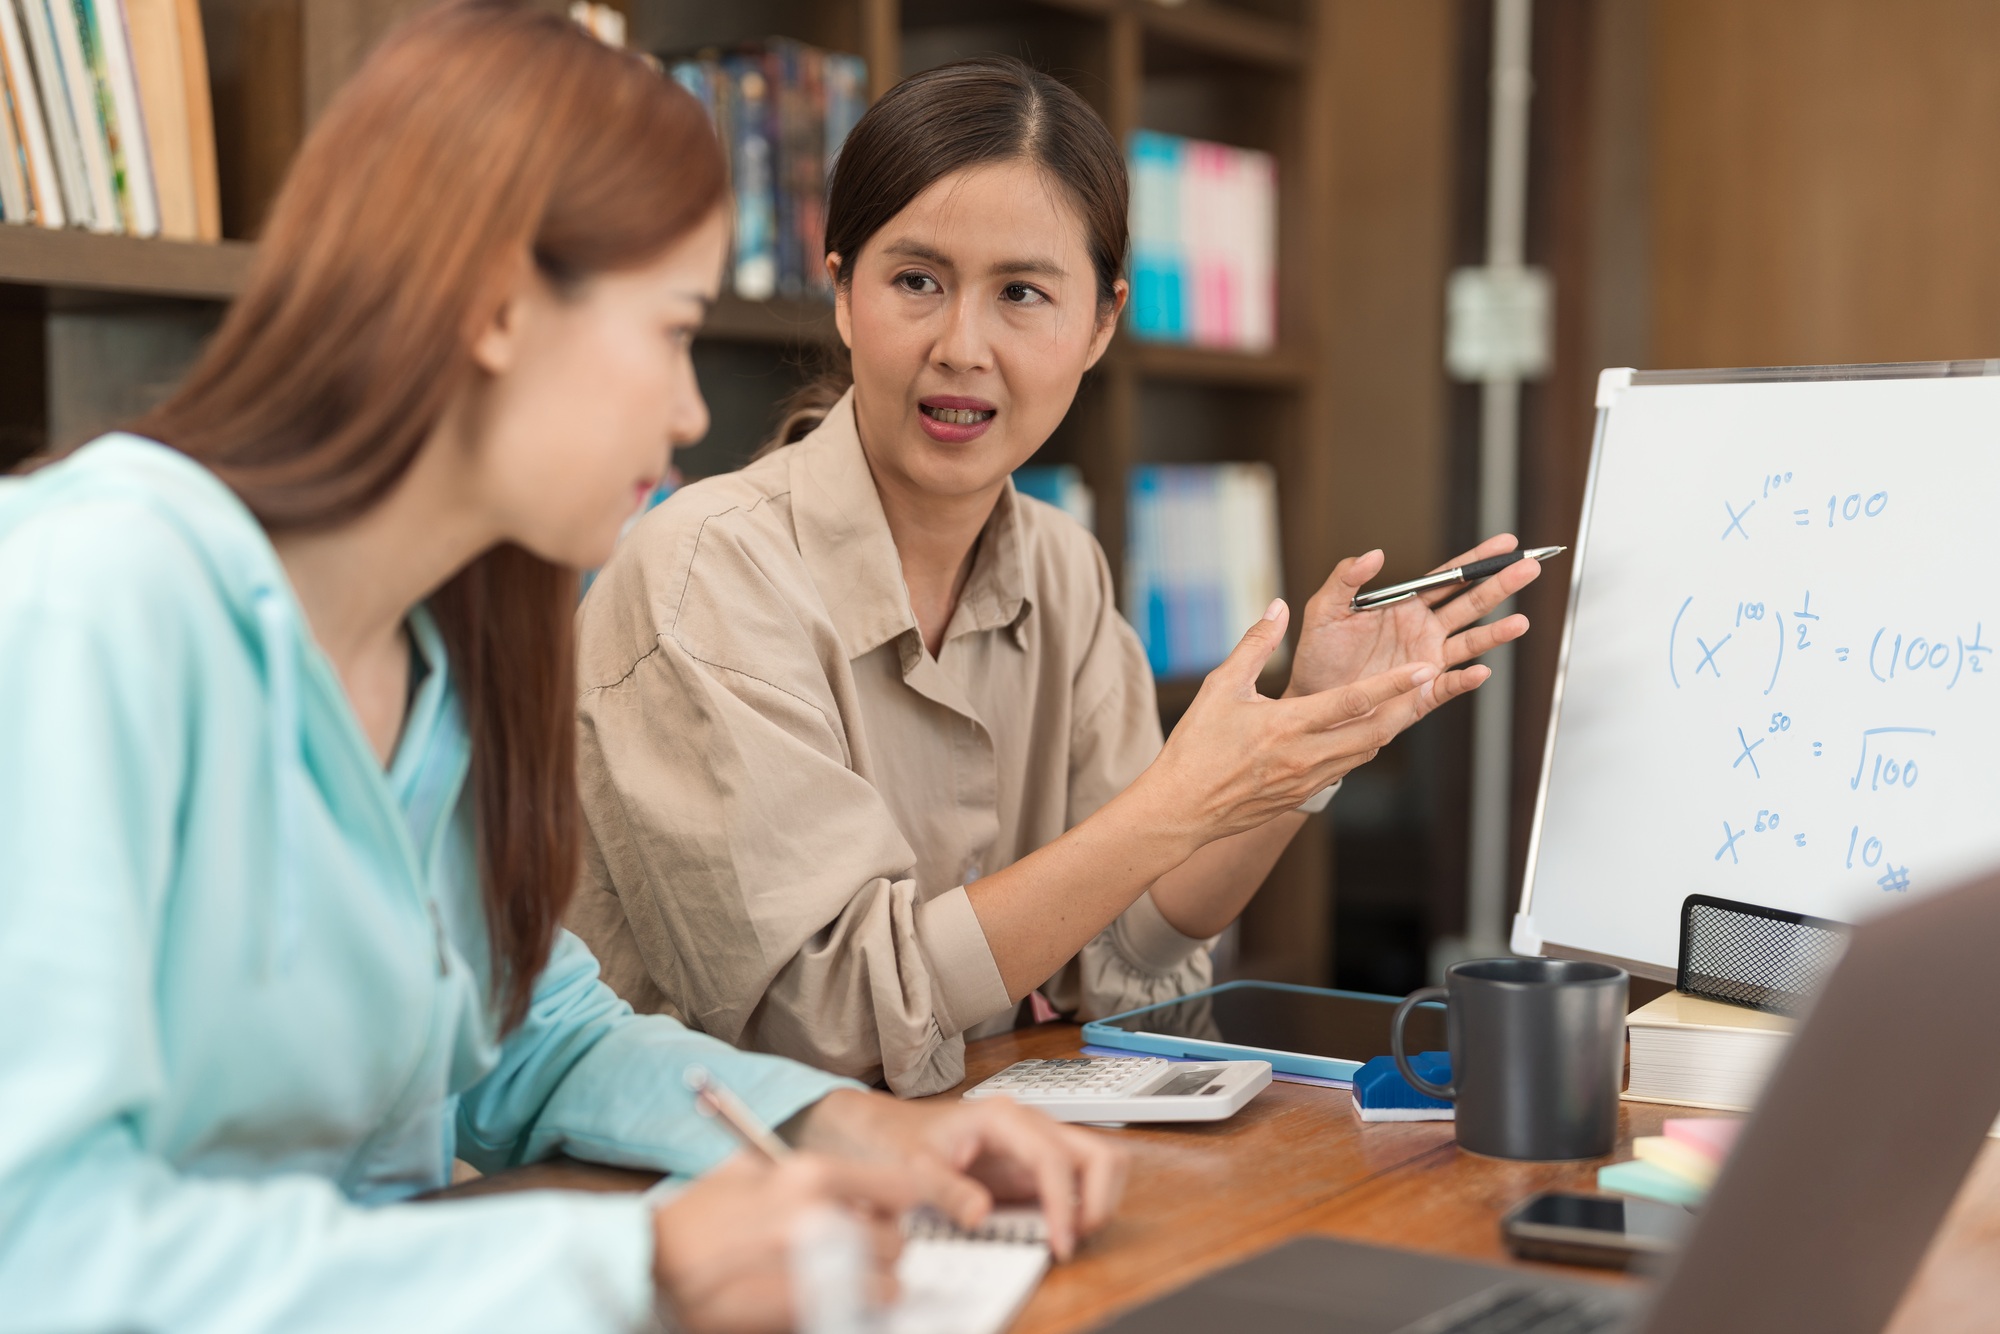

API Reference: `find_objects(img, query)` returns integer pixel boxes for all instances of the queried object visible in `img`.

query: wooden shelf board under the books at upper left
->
[0,224,256,302]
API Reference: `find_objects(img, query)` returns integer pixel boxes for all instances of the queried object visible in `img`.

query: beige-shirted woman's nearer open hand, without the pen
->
[1144,602,1438,844]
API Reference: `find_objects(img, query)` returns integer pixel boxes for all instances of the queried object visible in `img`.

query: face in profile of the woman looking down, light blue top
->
[466,210,728,568]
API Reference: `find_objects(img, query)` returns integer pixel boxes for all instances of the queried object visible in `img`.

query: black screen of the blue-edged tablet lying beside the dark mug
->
[1102,982,1446,1064]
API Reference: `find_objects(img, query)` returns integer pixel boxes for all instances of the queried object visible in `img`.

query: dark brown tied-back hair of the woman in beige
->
[758,56,1126,456]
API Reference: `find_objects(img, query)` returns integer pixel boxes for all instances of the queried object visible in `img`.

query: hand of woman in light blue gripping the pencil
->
[652,1154,922,1334]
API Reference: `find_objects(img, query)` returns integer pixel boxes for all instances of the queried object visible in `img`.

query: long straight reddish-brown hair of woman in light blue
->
[134,0,726,1028]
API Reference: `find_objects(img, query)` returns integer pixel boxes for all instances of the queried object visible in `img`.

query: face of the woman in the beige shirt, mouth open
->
[828,162,1124,496]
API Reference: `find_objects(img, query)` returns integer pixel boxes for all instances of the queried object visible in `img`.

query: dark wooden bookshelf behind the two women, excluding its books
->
[0,0,1336,982]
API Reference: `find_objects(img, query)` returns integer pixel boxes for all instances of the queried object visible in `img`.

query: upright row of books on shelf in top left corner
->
[0,0,222,240]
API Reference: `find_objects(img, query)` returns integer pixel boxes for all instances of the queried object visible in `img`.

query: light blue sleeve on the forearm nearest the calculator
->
[458,932,862,1174]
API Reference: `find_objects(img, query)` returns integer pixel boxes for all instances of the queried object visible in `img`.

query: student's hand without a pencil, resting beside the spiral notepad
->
[784,1090,1126,1260]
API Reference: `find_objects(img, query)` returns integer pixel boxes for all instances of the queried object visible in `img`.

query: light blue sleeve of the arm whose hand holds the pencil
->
[0,516,652,1334]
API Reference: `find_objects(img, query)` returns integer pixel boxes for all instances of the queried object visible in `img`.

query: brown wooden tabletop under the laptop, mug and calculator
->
[450,1024,2000,1334]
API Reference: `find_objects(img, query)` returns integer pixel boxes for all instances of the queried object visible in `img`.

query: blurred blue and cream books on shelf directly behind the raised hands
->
[1124,464,1284,678]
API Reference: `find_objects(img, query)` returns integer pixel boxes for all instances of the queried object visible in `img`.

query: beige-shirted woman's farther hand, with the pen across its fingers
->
[1286,532,1542,712]
